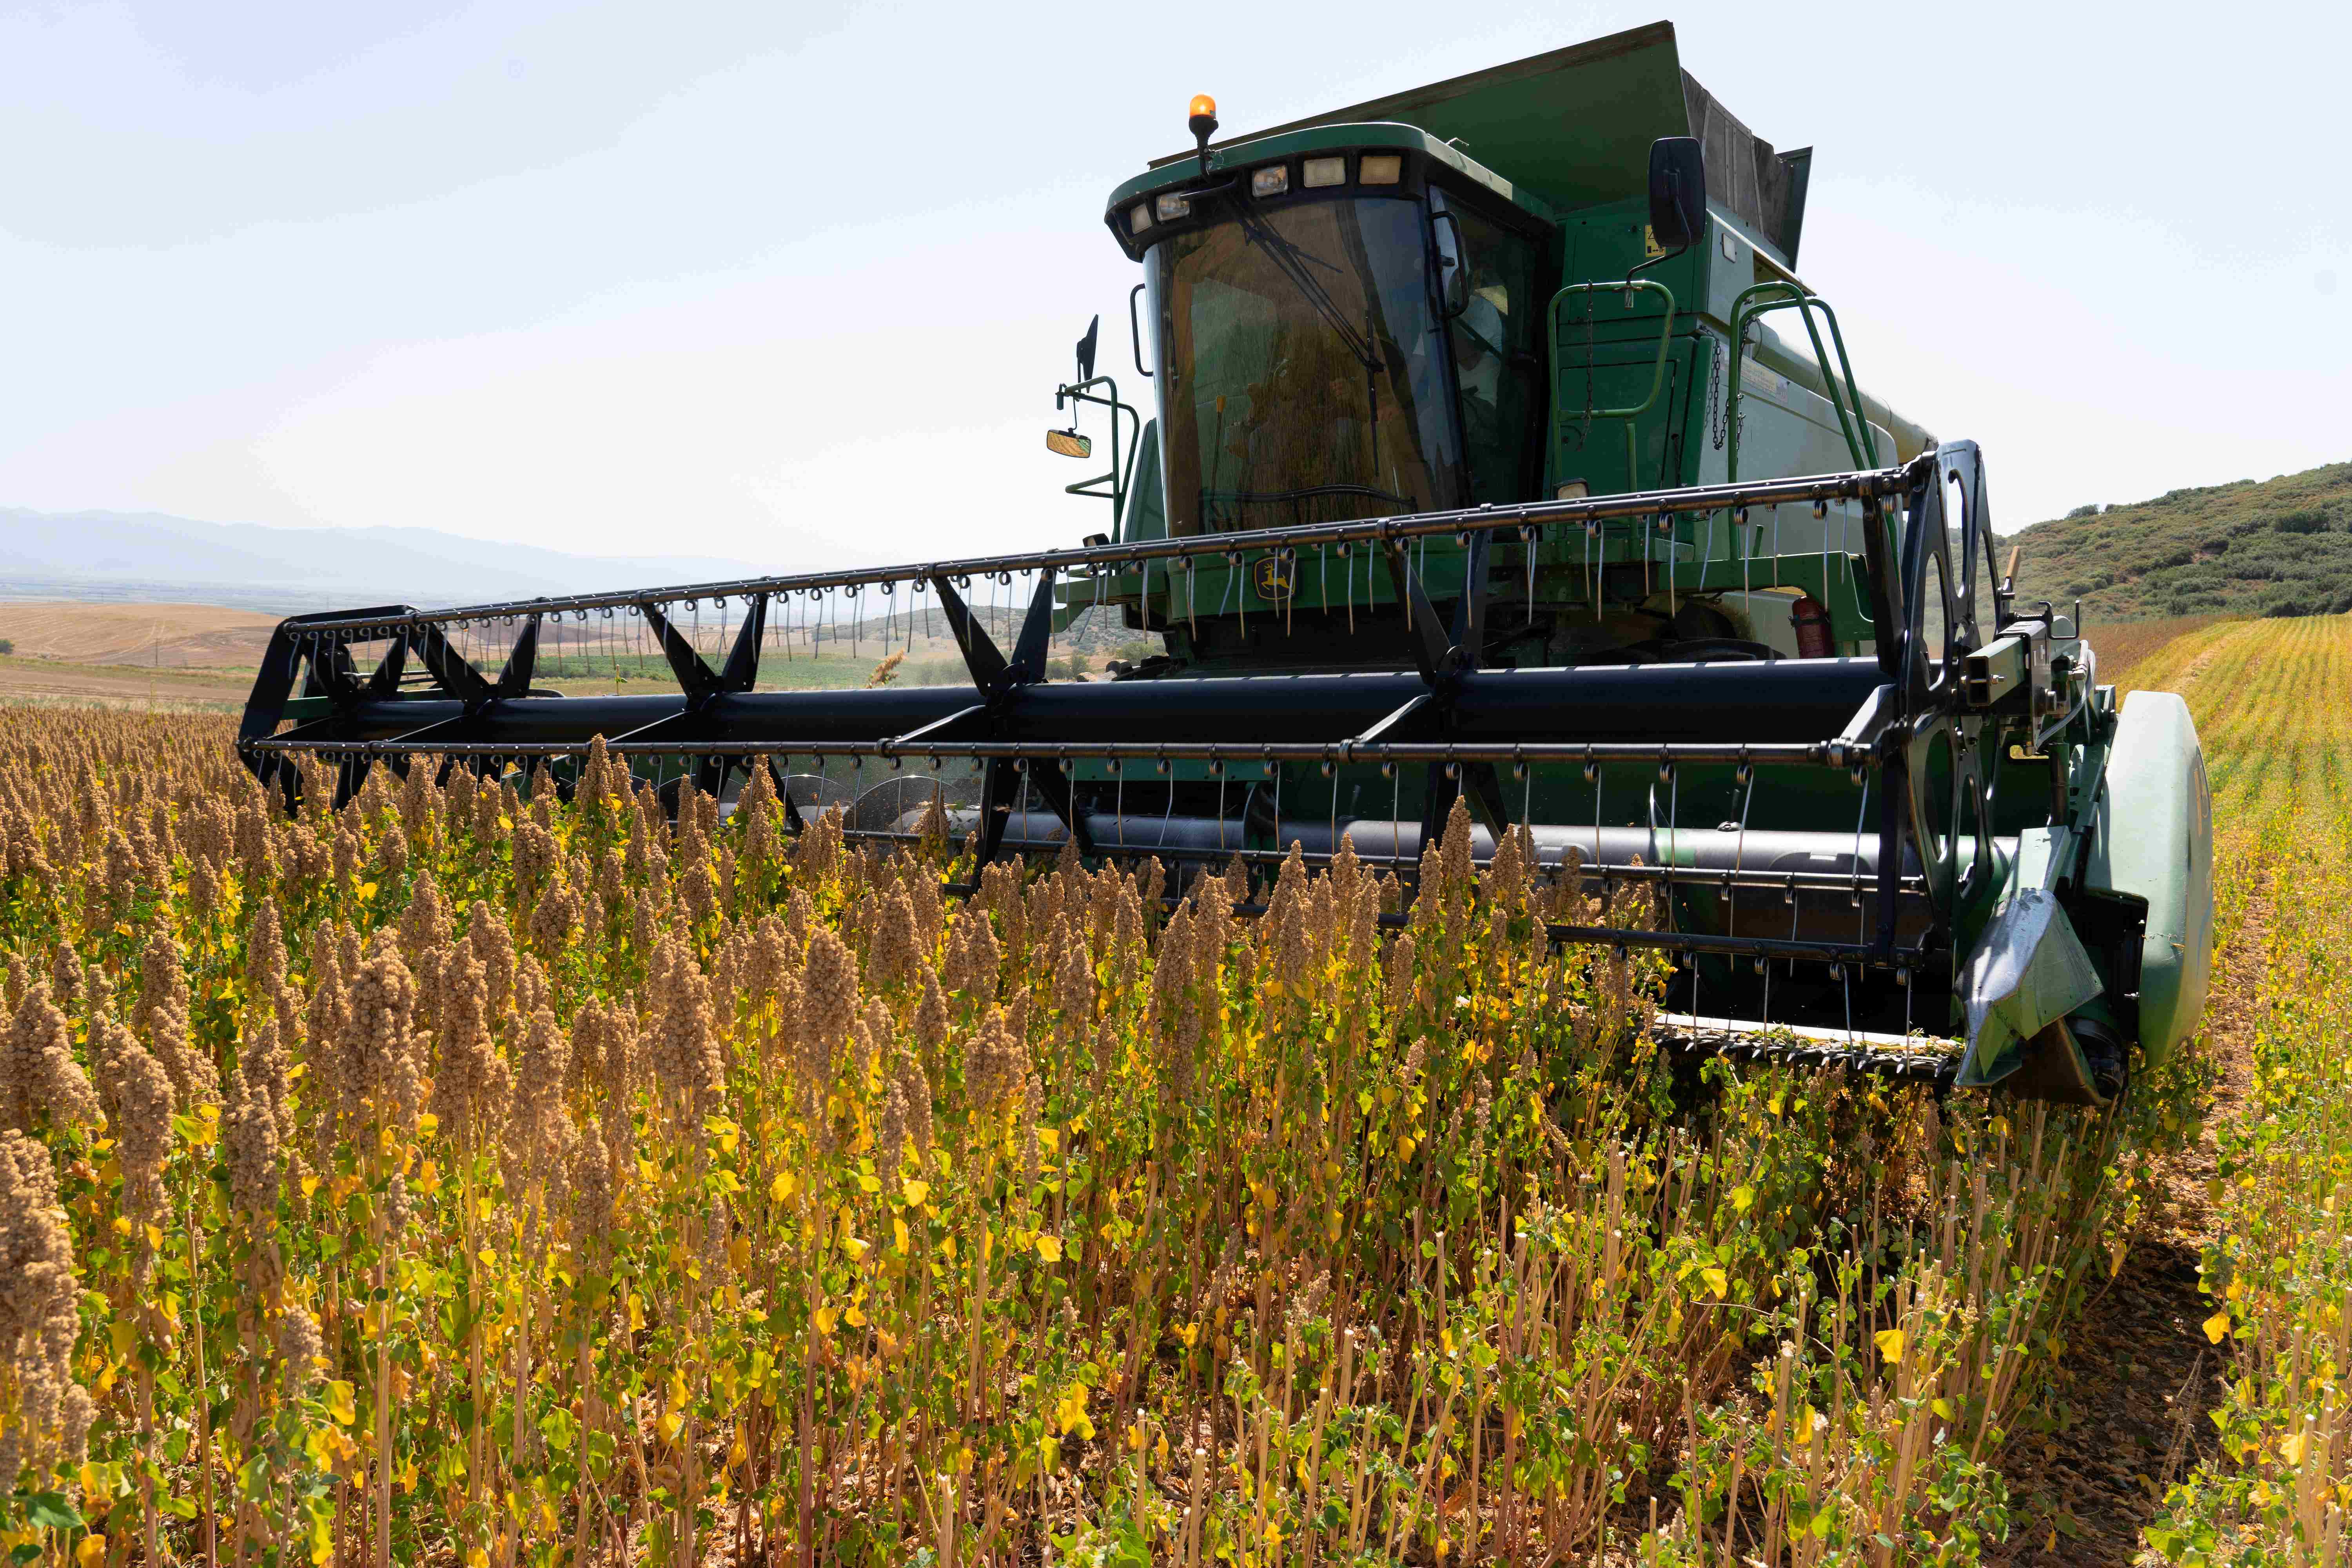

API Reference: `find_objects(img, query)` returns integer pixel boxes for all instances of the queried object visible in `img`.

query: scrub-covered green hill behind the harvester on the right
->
[2002,463,2352,621]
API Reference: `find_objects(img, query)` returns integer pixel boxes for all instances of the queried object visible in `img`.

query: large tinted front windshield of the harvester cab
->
[1150,198,1463,534]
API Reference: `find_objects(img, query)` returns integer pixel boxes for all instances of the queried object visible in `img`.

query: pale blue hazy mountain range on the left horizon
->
[0,508,779,609]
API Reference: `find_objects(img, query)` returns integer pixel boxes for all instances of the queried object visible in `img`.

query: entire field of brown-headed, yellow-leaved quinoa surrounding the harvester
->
[0,618,2352,1568]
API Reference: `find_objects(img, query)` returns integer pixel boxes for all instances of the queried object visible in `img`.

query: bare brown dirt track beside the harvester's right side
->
[1985,875,2270,1568]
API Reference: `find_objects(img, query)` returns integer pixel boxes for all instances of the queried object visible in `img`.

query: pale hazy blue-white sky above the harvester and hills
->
[0,0,2352,569]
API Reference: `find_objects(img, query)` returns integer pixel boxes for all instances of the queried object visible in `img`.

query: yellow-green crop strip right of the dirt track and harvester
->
[2147,618,2352,1563]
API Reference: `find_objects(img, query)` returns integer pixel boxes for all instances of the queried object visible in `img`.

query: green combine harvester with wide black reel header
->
[240,24,2213,1103]
